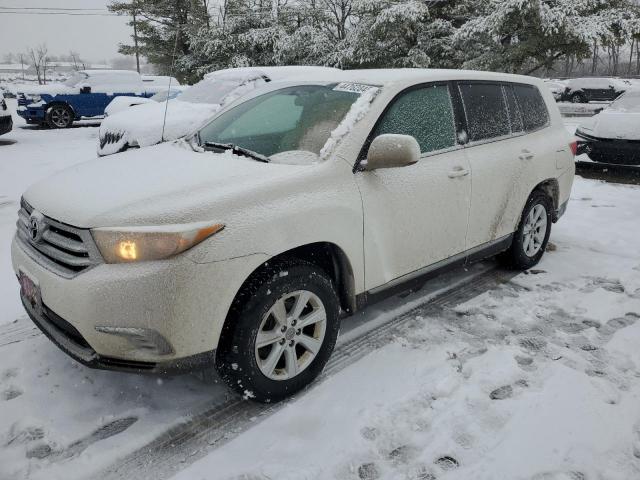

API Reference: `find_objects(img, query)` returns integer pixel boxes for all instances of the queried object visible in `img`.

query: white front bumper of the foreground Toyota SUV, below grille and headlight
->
[11,237,266,371]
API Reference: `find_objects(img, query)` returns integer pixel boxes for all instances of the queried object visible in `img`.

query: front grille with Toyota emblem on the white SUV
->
[17,199,102,278]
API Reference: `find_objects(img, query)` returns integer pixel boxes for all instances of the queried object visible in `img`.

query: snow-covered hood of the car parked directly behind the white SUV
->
[98,98,220,155]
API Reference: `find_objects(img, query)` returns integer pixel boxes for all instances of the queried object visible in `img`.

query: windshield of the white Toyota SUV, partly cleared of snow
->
[200,84,360,157]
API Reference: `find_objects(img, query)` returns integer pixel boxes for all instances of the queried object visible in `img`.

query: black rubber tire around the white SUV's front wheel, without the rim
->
[216,261,340,403]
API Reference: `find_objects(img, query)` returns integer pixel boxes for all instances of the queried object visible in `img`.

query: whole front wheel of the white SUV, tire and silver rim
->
[216,262,340,402]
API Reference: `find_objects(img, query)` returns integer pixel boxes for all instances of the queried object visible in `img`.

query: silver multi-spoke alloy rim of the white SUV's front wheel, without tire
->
[255,290,327,380]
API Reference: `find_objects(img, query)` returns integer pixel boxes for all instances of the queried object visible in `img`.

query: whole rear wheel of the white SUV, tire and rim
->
[501,190,553,270]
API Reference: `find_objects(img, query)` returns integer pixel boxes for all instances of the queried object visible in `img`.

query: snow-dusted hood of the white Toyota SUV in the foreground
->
[24,141,312,228]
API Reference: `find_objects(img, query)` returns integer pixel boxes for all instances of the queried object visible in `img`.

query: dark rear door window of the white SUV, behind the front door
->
[459,82,511,142]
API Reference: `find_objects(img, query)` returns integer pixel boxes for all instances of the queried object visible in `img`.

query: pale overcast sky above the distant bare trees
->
[0,0,132,62]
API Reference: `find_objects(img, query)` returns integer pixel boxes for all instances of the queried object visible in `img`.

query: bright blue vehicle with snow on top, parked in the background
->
[17,70,155,128]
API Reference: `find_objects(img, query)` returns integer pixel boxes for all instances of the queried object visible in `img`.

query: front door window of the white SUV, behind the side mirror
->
[373,85,456,153]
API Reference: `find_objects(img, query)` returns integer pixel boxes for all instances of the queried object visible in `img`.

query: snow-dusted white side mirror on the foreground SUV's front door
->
[365,134,420,170]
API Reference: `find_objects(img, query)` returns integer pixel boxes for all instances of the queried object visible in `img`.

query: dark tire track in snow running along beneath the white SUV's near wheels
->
[97,268,516,480]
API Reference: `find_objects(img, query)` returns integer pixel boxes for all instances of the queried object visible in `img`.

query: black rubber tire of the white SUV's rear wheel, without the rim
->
[499,190,553,270]
